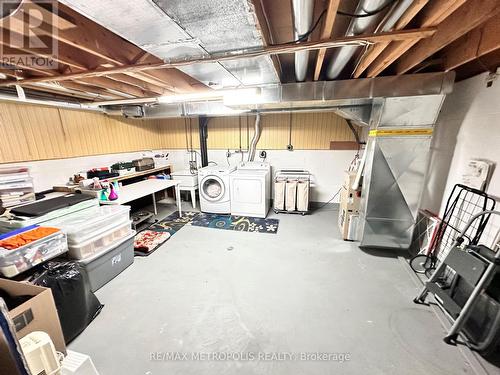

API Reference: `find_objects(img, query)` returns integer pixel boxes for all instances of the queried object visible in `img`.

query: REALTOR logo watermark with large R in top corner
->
[0,0,59,69]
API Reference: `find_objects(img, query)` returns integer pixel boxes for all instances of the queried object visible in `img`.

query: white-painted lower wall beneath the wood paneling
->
[0,150,355,202]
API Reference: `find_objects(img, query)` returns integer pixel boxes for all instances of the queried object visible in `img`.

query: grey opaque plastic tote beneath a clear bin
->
[78,232,135,292]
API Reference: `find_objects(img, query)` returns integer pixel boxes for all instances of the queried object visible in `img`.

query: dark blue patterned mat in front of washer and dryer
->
[191,213,279,234]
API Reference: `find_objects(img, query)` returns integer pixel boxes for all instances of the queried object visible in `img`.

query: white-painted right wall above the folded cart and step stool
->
[422,73,500,247]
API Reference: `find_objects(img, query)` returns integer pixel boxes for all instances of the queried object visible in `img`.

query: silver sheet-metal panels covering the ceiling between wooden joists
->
[62,0,279,88]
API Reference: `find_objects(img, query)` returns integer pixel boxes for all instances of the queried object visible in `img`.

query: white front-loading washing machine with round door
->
[198,165,236,214]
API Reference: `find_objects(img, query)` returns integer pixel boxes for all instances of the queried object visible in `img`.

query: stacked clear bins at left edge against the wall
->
[0,167,35,208]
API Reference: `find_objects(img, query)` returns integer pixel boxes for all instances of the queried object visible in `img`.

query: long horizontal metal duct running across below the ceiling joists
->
[132,72,455,120]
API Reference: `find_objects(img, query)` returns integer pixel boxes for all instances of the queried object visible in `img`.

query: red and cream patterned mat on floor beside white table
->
[134,211,198,256]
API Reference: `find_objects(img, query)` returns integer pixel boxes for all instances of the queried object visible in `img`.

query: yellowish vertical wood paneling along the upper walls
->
[0,103,354,163]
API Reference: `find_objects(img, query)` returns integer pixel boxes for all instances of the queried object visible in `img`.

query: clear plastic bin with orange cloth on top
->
[0,231,68,277]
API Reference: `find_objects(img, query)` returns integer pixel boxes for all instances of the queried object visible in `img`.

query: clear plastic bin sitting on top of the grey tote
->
[68,220,132,260]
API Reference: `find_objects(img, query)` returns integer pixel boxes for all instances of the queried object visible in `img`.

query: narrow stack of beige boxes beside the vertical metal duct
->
[338,171,361,241]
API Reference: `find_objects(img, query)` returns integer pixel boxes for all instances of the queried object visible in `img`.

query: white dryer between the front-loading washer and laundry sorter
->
[229,162,271,218]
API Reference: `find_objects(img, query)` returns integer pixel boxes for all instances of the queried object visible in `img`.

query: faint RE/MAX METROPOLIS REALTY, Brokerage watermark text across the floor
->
[149,352,351,363]
